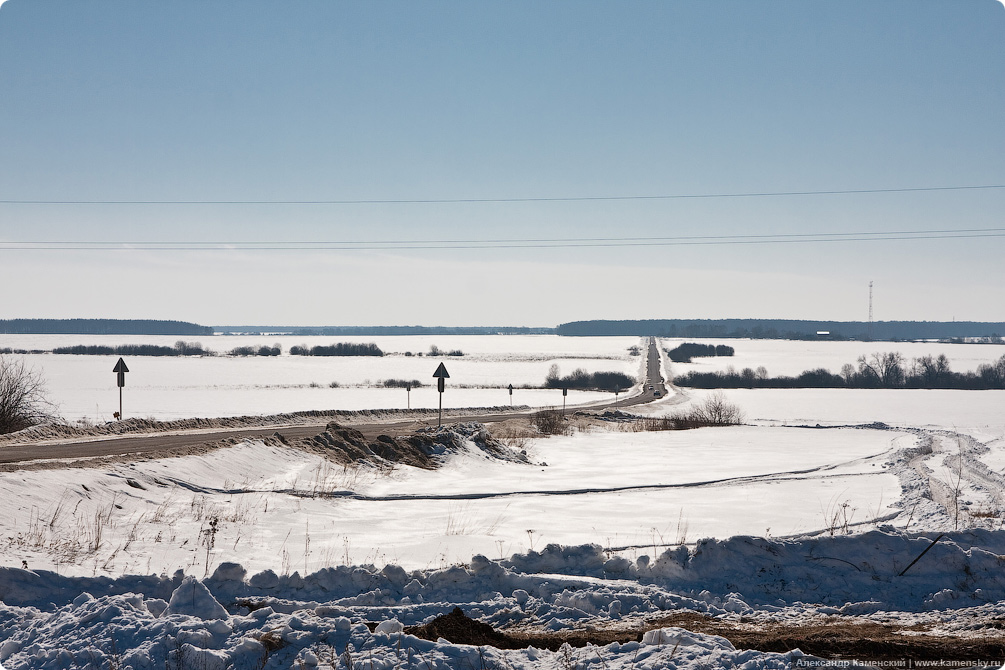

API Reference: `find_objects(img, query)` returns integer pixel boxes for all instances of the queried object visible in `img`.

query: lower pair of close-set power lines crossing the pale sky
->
[7,228,1005,251]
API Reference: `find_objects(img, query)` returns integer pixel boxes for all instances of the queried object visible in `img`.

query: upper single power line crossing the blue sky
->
[0,184,1005,205]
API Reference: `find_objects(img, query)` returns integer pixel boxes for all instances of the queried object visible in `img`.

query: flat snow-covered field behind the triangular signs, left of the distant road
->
[0,334,641,422]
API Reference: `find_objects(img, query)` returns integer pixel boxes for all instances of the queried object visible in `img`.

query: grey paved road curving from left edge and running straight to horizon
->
[0,338,666,463]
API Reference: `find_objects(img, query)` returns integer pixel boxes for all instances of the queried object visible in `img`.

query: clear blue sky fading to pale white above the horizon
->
[0,0,1005,325]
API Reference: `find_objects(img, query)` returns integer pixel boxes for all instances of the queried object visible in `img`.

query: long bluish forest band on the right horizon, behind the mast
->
[555,318,1005,341]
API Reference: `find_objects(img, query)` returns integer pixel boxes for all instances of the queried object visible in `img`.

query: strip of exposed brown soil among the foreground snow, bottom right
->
[405,608,1005,667]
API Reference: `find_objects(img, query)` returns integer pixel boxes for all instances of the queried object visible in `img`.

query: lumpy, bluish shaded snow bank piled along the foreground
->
[0,530,1005,670]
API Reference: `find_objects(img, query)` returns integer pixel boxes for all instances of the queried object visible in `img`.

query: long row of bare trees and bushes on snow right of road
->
[673,353,1005,390]
